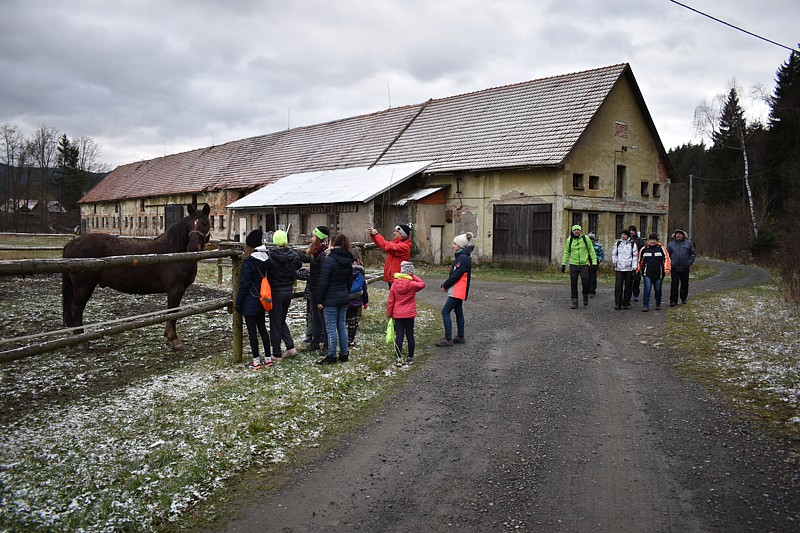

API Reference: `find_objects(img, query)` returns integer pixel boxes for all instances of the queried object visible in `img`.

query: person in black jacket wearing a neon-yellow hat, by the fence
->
[267,230,301,364]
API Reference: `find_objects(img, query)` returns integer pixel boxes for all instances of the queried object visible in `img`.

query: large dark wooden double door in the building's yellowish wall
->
[492,204,553,264]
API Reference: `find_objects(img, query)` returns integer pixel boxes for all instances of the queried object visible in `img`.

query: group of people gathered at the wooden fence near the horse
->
[234,224,474,370]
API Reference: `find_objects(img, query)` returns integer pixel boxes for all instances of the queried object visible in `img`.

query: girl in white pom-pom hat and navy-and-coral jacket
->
[436,231,475,346]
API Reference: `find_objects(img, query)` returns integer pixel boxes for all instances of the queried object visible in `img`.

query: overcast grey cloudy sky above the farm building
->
[0,0,800,168]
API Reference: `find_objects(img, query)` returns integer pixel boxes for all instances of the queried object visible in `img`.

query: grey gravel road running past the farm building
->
[219,263,800,532]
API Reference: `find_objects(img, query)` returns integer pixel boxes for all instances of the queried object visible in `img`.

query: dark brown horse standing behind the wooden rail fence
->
[62,205,211,350]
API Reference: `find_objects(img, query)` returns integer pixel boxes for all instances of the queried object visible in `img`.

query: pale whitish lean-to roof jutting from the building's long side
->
[228,161,431,209]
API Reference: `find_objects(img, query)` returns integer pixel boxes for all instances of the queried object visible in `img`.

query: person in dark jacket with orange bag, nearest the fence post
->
[233,229,274,370]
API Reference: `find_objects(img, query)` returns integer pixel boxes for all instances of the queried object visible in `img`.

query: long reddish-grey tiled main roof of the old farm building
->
[81,64,636,202]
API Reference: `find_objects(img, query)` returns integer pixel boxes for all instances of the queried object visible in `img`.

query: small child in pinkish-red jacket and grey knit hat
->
[386,261,425,366]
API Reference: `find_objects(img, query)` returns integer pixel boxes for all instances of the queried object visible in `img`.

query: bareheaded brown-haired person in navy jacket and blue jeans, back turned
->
[317,233,353,365]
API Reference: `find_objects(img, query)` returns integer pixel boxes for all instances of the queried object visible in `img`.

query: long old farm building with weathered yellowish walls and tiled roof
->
[81,64,674,264]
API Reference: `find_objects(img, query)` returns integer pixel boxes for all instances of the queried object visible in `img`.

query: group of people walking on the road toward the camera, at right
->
[561,224,697,313]
